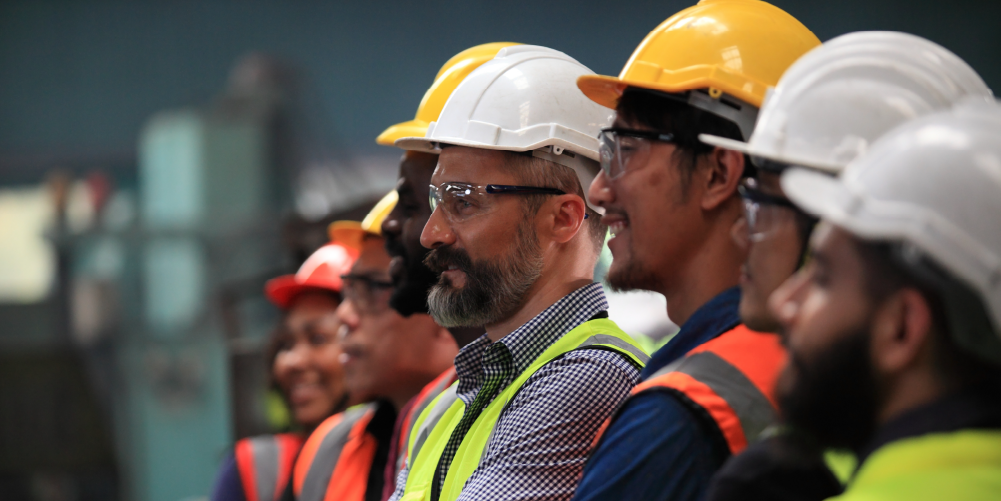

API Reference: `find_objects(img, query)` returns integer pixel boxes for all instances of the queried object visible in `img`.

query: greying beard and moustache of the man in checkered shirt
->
[424,226,543,328]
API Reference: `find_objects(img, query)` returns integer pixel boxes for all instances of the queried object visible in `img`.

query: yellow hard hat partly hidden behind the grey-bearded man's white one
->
[375,42,521,146]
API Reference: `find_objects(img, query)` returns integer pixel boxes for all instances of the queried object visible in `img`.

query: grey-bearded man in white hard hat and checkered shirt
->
[392,45,647,501]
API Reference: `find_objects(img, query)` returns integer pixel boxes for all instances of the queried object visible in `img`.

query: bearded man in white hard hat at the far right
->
[769,103,1001,500]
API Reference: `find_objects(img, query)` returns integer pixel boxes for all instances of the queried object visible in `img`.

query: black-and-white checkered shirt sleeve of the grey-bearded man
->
[458,350,639,501]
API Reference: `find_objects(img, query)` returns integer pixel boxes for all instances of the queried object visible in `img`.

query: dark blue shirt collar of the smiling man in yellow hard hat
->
[641,287,741,379]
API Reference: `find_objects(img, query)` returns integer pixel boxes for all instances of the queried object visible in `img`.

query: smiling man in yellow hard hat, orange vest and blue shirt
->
[575,0,820,501]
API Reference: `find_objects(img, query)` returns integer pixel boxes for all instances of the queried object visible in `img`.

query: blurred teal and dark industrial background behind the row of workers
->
[0,0,1001,501]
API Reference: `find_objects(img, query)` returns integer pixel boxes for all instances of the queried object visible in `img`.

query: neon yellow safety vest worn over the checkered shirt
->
[401,319,649,501]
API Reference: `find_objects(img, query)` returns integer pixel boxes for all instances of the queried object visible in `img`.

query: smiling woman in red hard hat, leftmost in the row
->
[212,243,358,501]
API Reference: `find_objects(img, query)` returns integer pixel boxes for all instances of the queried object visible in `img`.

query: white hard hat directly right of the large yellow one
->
[700,31,992,173]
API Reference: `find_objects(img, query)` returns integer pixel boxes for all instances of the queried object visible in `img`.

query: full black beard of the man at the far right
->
[778,322,878,451]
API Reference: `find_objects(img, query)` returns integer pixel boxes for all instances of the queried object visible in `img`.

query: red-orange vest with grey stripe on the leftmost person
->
[233,433,302,501]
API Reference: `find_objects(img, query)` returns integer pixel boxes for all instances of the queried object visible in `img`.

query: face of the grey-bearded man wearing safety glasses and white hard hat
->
[420,146,544,327]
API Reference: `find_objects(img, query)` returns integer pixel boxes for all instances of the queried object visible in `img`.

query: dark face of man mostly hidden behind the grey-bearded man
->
[382,151,437,317]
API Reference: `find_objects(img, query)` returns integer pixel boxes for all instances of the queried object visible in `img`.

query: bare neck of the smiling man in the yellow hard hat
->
[657,212,744,326]
